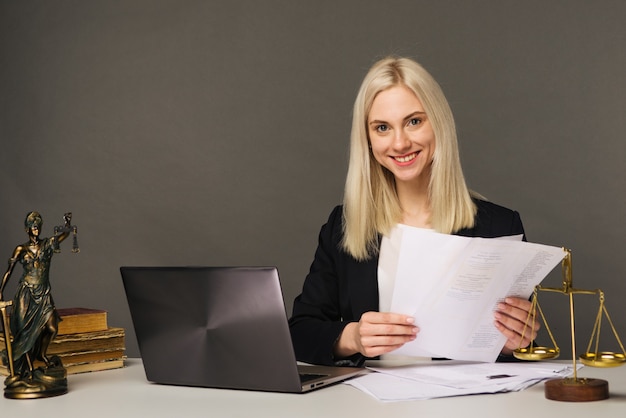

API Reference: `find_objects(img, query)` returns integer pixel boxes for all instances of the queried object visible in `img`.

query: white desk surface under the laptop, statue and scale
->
[0,359,626,418]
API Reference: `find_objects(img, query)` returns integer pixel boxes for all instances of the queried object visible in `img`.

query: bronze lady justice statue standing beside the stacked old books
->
[0,212,78,399]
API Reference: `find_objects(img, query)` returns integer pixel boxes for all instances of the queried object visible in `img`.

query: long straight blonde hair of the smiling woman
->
[342,57,476,260]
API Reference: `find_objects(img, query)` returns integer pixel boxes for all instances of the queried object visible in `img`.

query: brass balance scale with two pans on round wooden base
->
[513,249,626,402]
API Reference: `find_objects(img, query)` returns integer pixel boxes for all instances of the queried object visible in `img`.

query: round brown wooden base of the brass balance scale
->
[545,378,609,402]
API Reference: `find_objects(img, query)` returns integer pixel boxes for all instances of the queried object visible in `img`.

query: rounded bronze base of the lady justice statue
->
[4,356,67,399]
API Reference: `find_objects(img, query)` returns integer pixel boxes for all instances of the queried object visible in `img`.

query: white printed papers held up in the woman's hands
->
[387,227,565,362]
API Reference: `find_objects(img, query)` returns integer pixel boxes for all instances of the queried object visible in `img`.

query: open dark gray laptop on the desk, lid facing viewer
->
[120,267,363,393]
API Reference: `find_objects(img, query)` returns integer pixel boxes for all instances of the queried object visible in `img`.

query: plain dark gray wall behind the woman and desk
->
[0,0,626,356]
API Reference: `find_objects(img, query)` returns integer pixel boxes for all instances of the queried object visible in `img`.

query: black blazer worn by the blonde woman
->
[289,199,525,365]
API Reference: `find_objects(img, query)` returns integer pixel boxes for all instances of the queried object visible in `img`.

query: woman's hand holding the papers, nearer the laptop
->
[335,312,419,358]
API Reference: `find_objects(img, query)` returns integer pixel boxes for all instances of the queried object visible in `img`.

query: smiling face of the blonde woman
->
[367,85,435,184]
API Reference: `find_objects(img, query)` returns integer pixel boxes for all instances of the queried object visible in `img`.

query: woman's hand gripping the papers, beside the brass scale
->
[494,297,540,355]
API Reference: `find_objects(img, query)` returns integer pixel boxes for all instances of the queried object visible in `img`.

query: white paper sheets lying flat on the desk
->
[346,362,582,402]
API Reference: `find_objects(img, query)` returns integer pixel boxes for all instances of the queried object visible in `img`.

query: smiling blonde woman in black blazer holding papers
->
[290,58,538,365]
